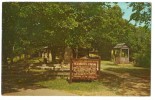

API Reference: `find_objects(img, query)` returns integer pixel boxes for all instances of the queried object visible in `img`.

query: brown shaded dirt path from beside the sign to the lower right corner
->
[103,70,151,96]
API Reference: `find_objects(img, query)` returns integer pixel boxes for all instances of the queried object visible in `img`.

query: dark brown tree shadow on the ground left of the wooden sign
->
[1,61,68,94]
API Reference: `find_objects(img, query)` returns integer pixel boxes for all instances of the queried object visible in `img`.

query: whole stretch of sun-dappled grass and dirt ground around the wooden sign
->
[2,61,150,96]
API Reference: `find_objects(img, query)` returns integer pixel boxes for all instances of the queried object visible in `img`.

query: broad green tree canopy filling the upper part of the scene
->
[2,2,151,66]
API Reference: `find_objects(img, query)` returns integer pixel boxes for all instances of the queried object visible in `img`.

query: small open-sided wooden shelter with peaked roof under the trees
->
[111,43,129,64]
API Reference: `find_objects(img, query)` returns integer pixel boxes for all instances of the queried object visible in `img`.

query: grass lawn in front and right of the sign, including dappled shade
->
[33,61,150,95]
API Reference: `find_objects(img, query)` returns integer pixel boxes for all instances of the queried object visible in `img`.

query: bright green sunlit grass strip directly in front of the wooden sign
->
[37,79,102,91]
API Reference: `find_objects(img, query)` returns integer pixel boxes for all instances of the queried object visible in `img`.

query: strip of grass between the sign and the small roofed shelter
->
[101,61,151,78]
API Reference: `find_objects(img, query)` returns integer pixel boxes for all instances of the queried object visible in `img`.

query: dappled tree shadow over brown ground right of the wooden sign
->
[101,68,150,96]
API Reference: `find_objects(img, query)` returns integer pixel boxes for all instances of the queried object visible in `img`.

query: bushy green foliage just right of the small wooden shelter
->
[129,27,151,67]
